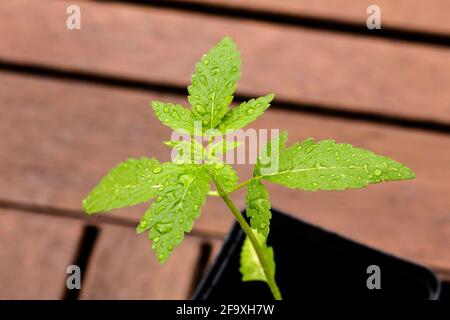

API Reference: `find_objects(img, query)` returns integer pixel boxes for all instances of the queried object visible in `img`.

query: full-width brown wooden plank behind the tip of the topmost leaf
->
[0,0,450,123]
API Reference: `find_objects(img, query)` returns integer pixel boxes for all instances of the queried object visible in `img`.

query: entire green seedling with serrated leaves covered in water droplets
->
[83,37,415,299]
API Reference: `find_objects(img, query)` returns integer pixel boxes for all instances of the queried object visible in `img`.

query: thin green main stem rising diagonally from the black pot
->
[211,175,283,300]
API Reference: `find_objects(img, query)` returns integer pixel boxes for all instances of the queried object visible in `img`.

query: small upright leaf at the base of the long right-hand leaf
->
[253,131,287,177]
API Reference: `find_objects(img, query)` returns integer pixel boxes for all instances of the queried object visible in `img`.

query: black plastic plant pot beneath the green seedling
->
[193,209,441,301]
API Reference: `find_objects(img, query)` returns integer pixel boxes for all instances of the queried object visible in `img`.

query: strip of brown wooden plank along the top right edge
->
[176,0,450,34]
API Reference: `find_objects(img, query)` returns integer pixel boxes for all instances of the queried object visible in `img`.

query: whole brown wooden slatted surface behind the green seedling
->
[0,0,450,299]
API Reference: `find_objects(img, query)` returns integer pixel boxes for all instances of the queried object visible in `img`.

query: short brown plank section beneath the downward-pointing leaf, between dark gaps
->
[81,226,199,299]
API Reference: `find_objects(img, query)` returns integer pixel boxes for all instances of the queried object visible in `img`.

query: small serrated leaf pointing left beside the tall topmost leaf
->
[152,101,194,135]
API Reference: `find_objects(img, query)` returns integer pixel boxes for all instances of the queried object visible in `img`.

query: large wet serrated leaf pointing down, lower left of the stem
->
[137,165,210,263]
